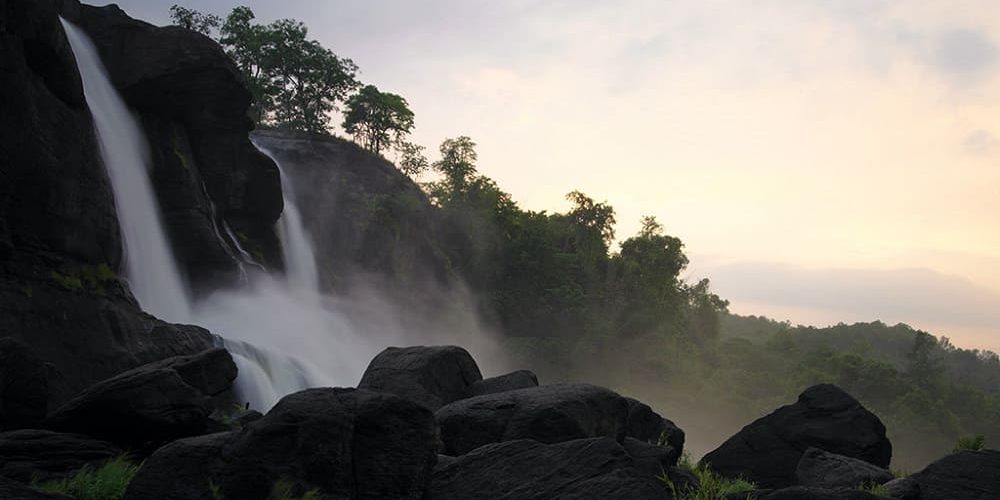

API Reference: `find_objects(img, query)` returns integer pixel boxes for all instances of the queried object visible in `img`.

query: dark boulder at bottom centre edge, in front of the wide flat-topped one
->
[427,438,670,500]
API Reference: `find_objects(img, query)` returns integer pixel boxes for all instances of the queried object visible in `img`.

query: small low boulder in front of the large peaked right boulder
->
[795,448,893,488]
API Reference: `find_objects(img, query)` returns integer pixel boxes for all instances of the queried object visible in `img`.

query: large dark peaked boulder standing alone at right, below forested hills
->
[702,384,892,488]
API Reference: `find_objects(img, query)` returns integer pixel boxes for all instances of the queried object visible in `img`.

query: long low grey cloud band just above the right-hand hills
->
[706,262,1000,331]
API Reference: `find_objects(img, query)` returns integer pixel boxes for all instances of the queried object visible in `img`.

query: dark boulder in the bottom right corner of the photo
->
[909,450,1000,500]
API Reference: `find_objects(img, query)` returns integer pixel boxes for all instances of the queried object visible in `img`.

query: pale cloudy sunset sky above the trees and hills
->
[113,0,1000,352]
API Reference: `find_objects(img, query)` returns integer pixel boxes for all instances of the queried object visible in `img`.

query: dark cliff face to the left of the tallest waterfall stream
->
[0,0,219,408]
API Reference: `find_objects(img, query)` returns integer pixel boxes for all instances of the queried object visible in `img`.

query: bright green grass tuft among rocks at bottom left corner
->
[37,456,139,500]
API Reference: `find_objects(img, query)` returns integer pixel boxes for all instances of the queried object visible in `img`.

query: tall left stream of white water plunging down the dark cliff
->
[60,18,191,322]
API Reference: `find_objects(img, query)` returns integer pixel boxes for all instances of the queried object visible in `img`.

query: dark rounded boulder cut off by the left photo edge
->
[0,337,49,430]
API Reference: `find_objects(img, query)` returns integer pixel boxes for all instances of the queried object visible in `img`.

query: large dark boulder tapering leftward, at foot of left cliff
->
[45,349,236,448]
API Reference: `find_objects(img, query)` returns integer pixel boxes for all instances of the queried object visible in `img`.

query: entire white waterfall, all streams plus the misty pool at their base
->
[62,20,506,411]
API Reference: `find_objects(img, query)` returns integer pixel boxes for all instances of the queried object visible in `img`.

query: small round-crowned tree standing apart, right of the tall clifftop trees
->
[343,85,413,154]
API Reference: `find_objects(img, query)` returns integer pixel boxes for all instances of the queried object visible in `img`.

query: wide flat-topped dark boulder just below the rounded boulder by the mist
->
[436,384,628,456]
